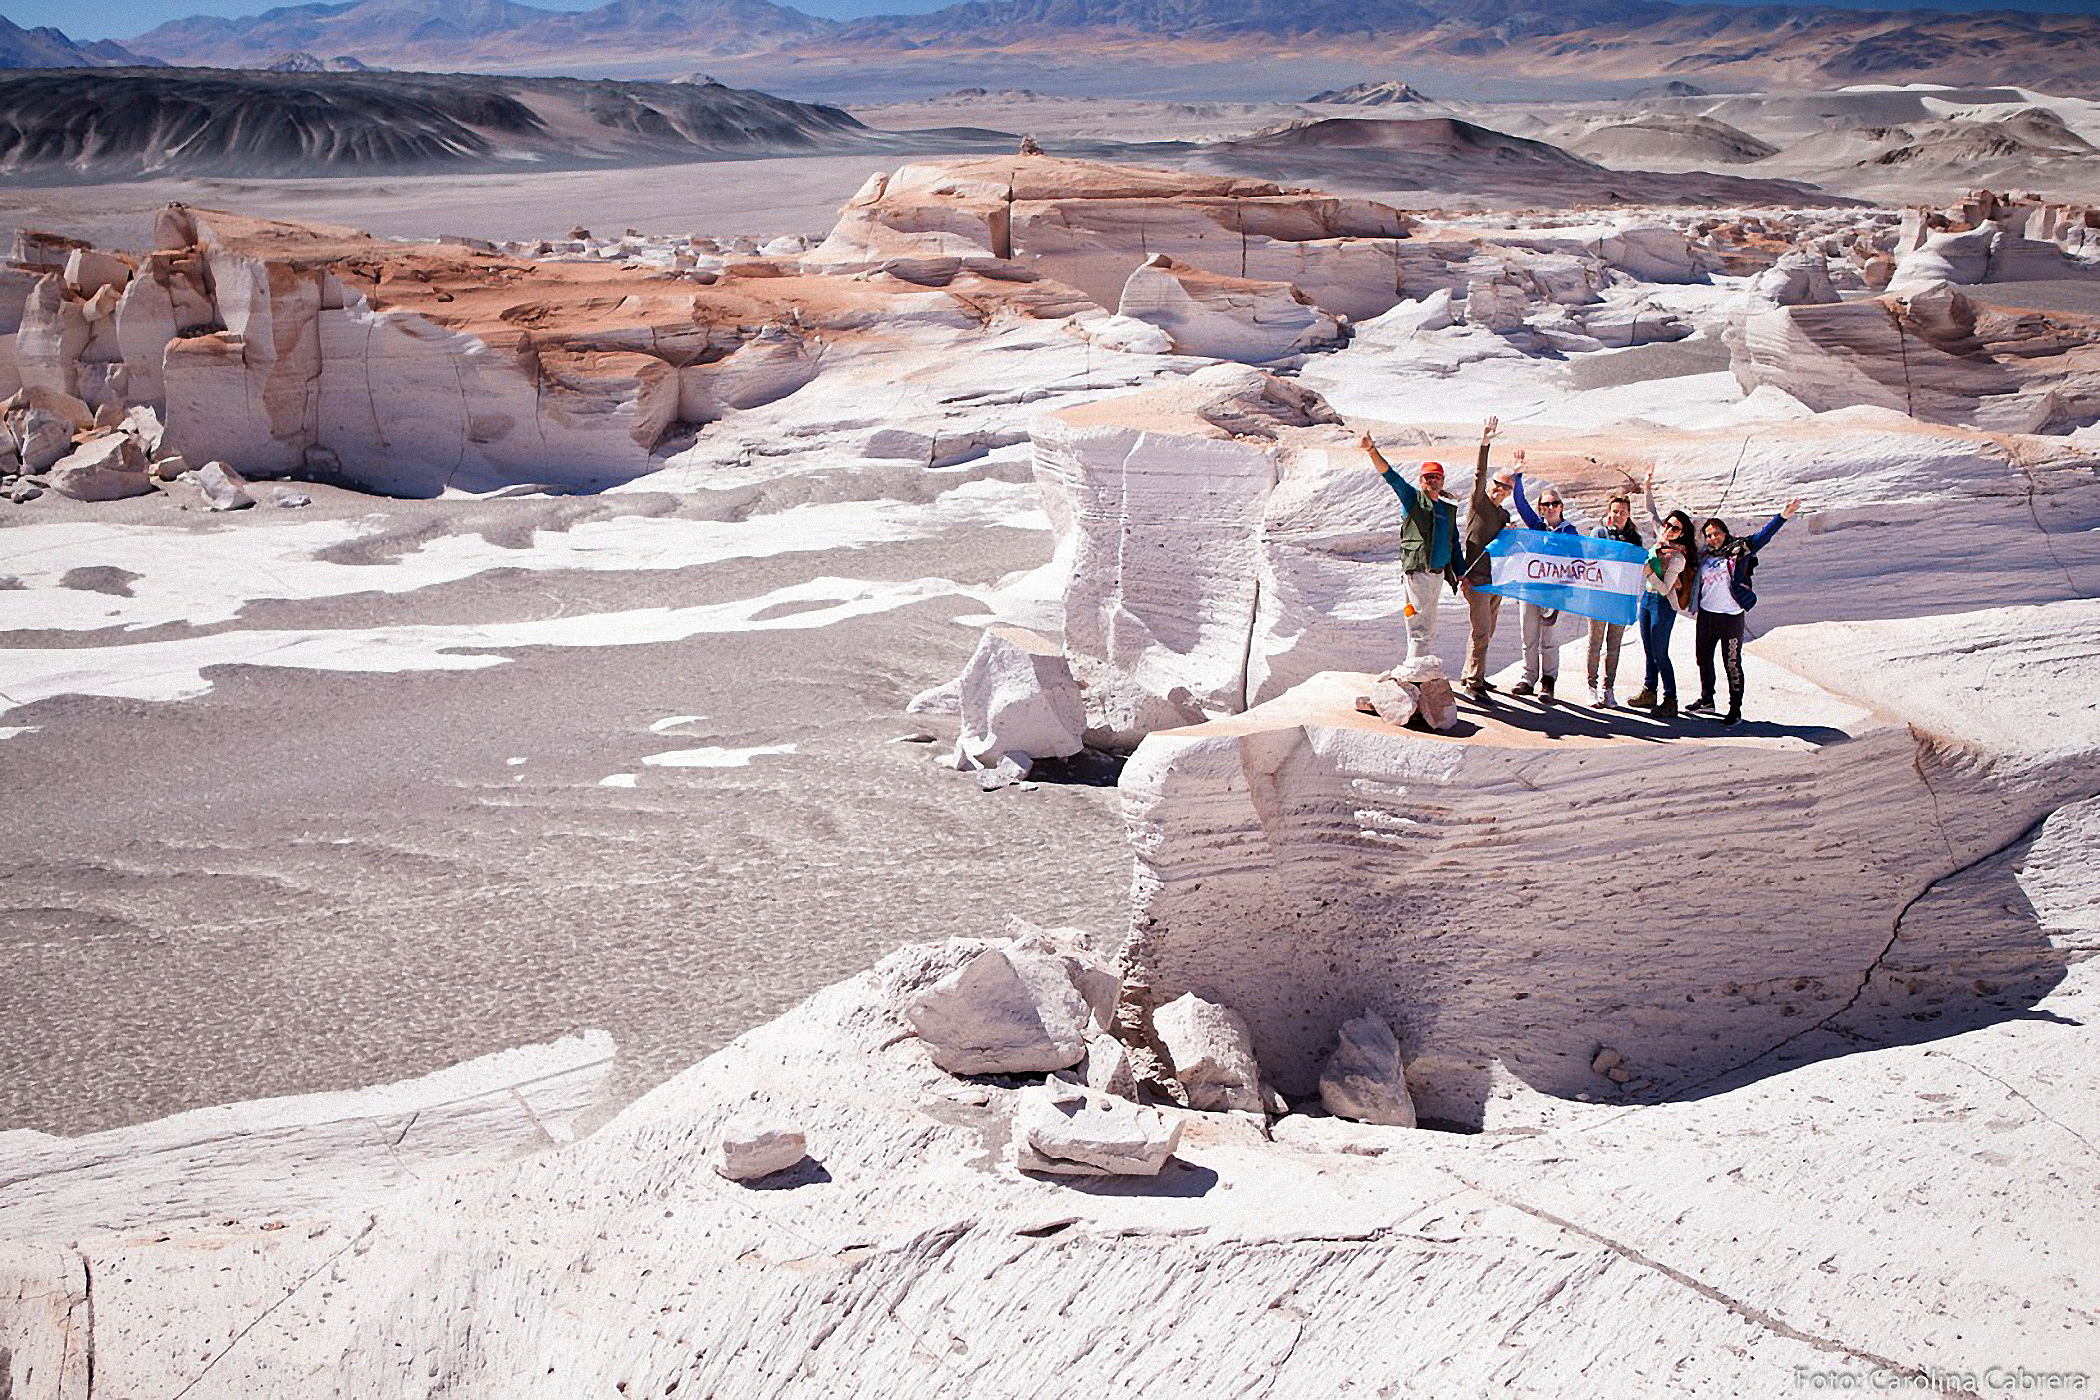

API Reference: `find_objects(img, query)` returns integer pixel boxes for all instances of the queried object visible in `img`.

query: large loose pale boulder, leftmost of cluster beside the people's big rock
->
[905,947,1090,1075]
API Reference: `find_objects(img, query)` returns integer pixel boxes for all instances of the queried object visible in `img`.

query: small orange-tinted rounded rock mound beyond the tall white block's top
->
[1115,252,1342,365]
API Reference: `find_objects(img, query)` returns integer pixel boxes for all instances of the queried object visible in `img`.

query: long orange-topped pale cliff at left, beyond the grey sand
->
[0,208,1084,495]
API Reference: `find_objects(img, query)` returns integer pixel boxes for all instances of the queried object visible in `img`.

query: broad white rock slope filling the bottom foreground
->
[0,793,2100,1400]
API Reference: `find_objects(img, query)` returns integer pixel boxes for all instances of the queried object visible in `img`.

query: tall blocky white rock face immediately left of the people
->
[1033,365,1436,745]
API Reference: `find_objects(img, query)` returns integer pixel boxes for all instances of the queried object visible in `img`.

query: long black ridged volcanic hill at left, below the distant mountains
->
[0,69,867,181]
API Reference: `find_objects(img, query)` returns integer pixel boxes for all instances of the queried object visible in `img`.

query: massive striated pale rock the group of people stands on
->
[1121,602,2100,1125]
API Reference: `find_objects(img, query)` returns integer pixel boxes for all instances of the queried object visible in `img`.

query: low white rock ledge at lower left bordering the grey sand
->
[0,1031,613,1240]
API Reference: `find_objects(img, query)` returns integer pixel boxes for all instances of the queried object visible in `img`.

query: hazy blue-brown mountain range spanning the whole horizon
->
[12,0,2100,92]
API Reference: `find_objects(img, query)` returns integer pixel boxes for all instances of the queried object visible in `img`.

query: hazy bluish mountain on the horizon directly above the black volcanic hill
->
[132,0,834,71]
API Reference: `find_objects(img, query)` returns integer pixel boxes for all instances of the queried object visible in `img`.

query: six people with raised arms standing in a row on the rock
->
[1359,418,1802,724]
